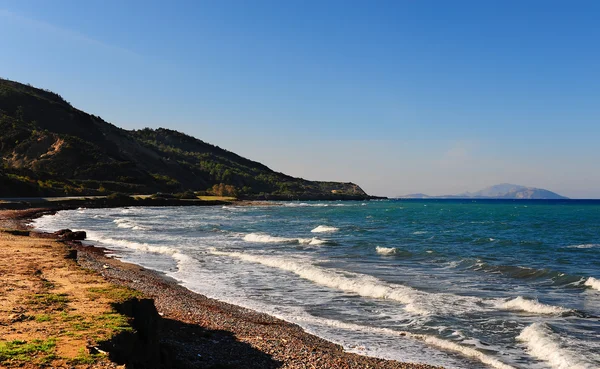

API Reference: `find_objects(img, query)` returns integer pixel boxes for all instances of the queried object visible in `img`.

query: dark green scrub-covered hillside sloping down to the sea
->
[0,79,368,199]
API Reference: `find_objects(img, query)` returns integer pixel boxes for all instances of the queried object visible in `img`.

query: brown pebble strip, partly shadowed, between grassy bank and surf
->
[0,208,440,369]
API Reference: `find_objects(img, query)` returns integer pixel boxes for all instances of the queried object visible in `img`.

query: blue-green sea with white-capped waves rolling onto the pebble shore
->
[33,199,600,369]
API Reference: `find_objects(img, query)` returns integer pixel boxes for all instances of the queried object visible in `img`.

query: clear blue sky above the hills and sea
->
[0,0,600,198]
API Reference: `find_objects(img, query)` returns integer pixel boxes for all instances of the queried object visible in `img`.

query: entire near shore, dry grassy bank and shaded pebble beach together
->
[0,209,440,368]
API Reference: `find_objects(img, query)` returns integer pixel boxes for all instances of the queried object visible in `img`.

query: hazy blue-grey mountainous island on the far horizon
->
[399,183,567,200]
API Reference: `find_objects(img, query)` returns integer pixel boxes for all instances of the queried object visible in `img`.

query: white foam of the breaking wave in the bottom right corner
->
[517,323,594,369]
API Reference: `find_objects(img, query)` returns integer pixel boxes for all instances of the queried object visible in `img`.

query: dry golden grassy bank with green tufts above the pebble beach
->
[0,232,141,368]
